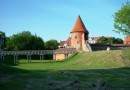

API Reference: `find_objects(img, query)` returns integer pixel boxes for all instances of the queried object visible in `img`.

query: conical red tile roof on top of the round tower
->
[71,16,88,33]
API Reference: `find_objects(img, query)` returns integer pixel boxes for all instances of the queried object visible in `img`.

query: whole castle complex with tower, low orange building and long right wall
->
[54,16,130,60]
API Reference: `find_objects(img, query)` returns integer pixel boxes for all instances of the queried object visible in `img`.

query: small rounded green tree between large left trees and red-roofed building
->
[45,39,59,50]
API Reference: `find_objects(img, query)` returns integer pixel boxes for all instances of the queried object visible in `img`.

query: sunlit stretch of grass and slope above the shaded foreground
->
[16,50,127,70]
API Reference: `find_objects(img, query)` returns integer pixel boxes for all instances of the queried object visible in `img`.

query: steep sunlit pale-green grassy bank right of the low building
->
[63,51,123,68]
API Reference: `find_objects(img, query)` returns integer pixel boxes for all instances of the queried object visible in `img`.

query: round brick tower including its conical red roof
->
[70,16,89,51]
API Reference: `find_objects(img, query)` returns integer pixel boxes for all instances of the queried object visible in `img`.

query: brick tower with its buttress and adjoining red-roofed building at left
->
[60,16,89,51]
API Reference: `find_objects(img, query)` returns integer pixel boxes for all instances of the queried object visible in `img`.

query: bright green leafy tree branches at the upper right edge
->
[114,0,130,36]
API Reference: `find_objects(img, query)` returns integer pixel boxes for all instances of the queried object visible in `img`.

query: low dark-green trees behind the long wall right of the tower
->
[97,36,123,44]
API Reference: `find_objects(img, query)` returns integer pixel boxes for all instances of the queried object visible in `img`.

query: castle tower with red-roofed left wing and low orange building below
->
[53,16,91,60]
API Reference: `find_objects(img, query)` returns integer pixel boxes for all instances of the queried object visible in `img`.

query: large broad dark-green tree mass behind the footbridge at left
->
[6,31,44,50]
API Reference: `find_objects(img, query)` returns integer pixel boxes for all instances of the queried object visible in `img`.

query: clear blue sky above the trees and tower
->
[0,0,126,41]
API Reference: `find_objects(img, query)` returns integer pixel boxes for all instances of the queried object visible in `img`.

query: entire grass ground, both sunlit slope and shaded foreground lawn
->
[0,50,130,90]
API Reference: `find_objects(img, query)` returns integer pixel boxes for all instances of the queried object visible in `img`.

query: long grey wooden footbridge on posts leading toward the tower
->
[0,50,77,64]
